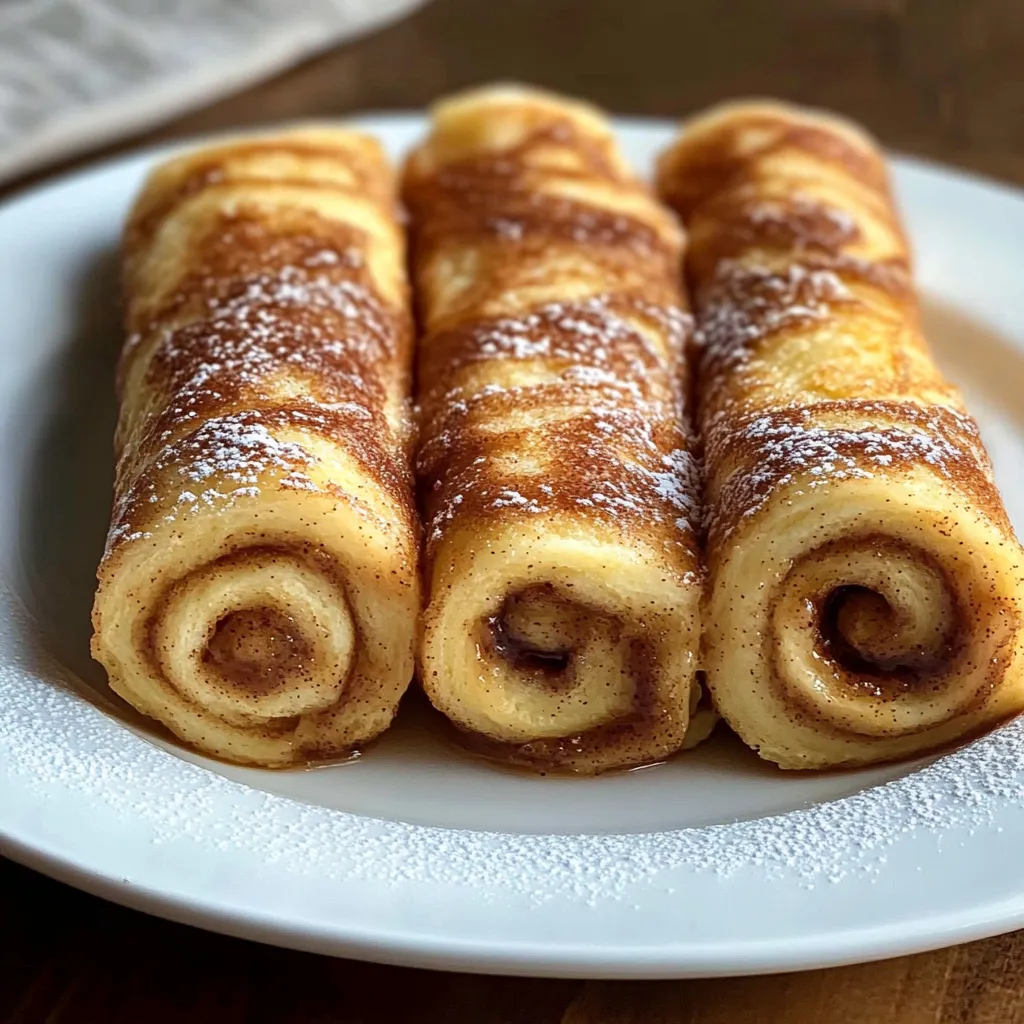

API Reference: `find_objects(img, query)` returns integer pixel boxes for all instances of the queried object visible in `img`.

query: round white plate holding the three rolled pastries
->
[0,117,1024,977]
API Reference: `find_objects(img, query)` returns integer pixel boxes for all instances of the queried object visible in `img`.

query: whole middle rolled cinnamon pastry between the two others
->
[402,87,702,773]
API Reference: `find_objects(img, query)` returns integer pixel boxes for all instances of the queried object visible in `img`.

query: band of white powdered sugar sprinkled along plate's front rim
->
[0,594,1024,905]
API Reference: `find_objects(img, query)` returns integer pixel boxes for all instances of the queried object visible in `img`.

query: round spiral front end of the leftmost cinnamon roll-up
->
[92,475,416,766]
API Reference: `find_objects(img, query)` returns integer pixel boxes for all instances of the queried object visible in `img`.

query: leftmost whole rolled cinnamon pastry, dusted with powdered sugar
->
[92,127,419,767]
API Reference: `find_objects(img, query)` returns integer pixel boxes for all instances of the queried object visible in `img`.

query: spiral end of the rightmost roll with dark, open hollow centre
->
[706,469,1024,768]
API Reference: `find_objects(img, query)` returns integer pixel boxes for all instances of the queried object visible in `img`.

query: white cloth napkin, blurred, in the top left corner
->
[0,0,423,181]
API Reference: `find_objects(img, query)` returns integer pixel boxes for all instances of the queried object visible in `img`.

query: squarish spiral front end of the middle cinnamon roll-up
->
[422,522,698,771]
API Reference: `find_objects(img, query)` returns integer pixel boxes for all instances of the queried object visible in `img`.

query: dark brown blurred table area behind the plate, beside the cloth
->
[6,0,1024,194]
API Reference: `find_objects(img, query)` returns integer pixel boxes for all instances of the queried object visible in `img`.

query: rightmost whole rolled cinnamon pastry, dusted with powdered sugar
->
[658,102,1024,768]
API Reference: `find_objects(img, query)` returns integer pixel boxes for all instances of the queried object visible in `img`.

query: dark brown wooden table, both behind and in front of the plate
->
[8,0,1024,1024]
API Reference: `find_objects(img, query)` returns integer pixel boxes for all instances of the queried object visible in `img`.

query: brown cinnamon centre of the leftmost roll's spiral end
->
[203,608,312,693]
